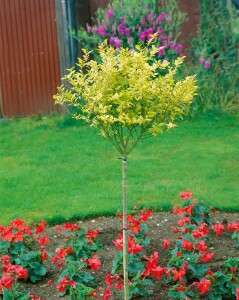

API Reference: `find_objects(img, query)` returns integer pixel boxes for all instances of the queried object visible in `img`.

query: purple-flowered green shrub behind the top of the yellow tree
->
[73,0,185,60]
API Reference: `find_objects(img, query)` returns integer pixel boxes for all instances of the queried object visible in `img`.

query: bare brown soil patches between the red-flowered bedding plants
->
[21,212,239,300]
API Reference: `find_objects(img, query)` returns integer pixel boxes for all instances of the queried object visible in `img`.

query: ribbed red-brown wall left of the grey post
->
[0,0,60,117]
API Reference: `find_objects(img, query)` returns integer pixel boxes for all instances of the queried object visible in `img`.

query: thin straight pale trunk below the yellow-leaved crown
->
[122,155,129,300]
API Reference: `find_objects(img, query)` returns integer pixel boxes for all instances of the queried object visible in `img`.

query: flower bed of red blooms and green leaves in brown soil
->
[0,192,239,299]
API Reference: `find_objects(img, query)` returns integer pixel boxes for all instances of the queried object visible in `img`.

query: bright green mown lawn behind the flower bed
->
[0,116,239,224]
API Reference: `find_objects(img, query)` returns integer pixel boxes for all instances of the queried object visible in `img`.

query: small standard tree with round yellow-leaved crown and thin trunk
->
[55,43,196,300]
